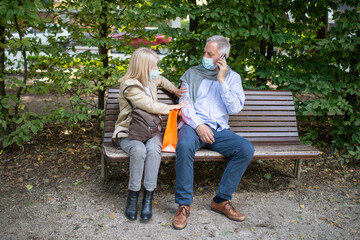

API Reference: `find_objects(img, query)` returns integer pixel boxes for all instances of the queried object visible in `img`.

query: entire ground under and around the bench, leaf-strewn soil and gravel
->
[0,128,360,240]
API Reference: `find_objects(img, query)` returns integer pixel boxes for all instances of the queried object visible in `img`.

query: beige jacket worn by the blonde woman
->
[112,75,176,139]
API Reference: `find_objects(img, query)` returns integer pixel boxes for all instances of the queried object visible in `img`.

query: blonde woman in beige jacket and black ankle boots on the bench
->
[113,48,187,221]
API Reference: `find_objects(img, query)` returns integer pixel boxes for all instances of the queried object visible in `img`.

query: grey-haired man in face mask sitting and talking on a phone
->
[173,35,254,229]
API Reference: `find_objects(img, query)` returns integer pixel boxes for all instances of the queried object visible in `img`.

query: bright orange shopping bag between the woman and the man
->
[161,109,181,152]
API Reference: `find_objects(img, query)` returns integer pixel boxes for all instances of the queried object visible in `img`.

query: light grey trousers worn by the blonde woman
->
[118,134,162,191]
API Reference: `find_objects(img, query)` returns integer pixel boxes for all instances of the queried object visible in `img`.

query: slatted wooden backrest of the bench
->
[103,88,300,145]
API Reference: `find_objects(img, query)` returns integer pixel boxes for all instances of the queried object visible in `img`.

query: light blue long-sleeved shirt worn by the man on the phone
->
[180,71,245,131]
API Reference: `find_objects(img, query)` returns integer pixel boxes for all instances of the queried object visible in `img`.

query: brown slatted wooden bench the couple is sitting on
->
[101,88,319,179]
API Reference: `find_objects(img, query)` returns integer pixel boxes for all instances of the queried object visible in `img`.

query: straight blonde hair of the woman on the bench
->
[120,47,159,87]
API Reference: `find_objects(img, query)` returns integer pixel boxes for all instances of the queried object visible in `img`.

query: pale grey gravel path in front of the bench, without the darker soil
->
[0,176,360,239]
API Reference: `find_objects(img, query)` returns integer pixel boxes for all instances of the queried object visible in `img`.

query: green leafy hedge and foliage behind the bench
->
[0,0,360,161]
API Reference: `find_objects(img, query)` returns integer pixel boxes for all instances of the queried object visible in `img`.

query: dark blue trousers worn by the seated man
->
[175,124,254,205]
